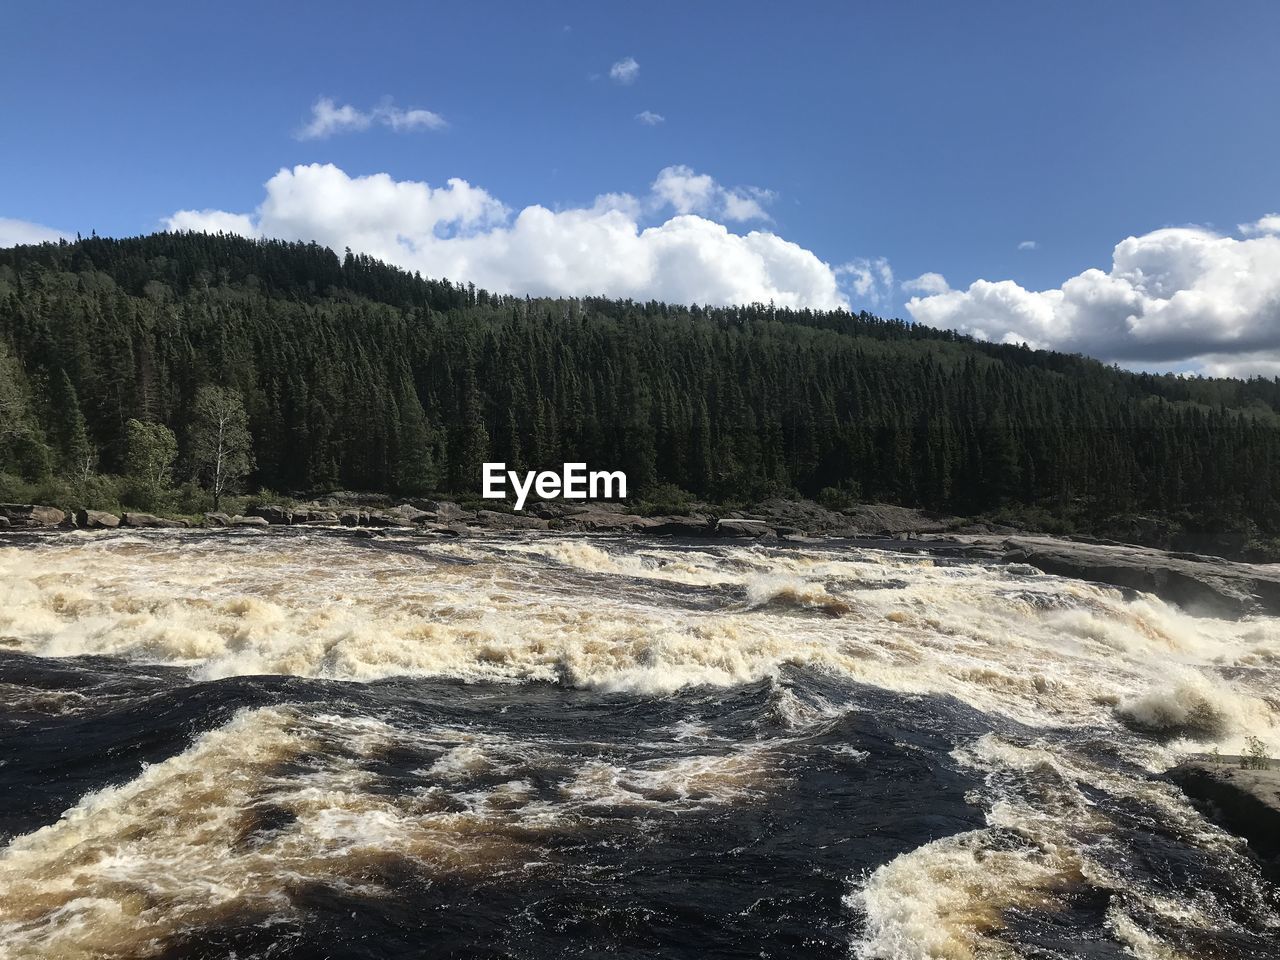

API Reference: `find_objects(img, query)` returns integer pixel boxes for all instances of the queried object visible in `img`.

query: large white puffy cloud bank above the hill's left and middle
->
[168,164,855,308]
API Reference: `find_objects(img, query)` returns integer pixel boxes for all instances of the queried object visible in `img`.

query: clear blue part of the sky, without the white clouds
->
[0,0,1280,370]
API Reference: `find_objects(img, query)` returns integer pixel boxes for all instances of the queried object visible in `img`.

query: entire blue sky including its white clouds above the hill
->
[0,0,1280,376]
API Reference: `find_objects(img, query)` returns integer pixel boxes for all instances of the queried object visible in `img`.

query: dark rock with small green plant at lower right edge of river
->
[1169,756,1280,872]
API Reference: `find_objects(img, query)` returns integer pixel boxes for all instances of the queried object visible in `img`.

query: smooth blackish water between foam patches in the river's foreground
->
[0,654,1276,959]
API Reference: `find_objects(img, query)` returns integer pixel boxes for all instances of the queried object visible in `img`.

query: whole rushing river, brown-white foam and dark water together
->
[0,531,1280,960]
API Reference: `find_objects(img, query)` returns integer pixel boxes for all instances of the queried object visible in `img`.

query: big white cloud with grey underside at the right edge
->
[906,225,1280,372]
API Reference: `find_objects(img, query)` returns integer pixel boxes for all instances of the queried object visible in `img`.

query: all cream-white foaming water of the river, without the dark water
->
[0,534,1280,960]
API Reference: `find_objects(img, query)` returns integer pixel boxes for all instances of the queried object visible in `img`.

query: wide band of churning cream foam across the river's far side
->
[0,536,1280,749]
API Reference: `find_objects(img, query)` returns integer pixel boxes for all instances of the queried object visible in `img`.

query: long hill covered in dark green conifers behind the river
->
[0,233,1280,552]
